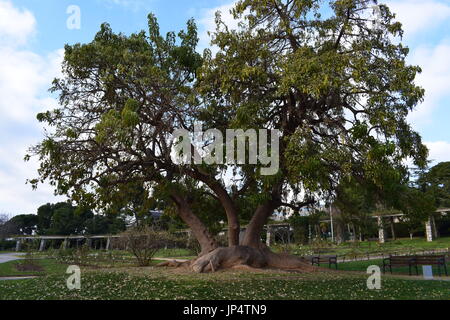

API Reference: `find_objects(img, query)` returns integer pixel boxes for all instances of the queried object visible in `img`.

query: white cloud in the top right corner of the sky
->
[386,0,450,38]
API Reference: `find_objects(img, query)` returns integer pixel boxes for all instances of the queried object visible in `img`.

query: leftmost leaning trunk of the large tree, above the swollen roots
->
[171,194,217,256]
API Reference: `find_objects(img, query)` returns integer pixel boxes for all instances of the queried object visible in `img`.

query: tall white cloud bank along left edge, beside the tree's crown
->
[0,0,63,215]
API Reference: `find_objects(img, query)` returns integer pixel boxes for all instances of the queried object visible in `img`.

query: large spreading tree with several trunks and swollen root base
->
[31,0,427,272]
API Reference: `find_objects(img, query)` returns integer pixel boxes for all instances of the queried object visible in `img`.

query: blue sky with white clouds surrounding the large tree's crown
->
[0,0,450,215]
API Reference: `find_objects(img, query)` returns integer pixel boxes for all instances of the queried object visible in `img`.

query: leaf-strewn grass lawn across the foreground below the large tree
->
[0,260,450,300]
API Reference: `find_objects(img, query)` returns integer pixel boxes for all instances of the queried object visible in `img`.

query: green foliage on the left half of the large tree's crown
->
[26,14,202,210]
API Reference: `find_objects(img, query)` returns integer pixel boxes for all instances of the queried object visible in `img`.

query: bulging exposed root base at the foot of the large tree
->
[158,246,320,273]
